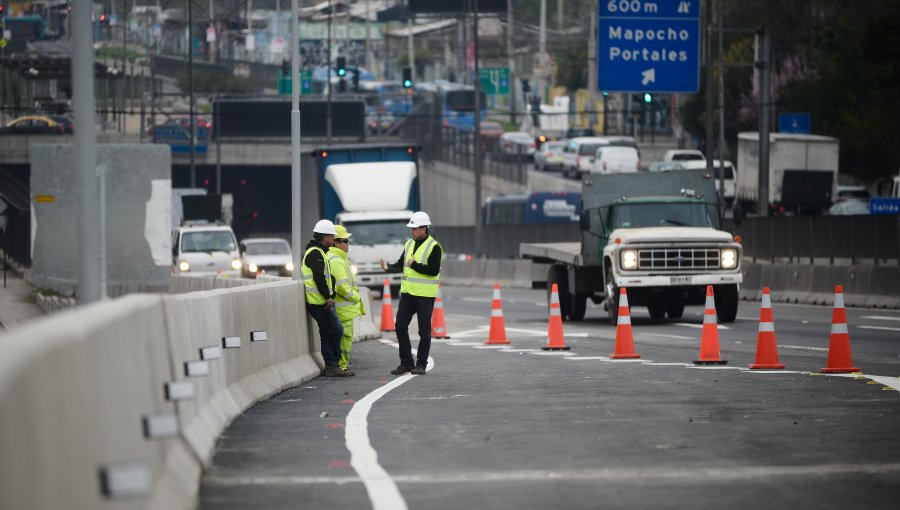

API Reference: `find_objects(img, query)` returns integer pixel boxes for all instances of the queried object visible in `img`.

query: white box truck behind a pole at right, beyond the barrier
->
[735,132,840,214]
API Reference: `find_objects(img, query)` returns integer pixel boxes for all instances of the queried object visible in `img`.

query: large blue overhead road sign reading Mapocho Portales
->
[597,0,700,93]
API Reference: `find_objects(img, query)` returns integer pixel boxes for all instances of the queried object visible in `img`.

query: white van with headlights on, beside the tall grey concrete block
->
[172,224,241,278]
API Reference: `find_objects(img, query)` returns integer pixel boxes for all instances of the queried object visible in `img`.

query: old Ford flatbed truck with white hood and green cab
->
[519,170,743,324]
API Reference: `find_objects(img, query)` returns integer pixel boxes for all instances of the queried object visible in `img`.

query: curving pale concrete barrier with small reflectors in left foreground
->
[0,282,321,510]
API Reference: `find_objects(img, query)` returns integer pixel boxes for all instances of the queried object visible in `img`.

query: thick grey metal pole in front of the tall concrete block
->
[72,2,102,304]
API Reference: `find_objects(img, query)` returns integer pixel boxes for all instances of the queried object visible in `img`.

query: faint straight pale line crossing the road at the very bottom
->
[204,463,900,486]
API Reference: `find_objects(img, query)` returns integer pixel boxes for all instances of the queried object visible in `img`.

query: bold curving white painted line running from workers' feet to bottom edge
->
[344,339,434,510]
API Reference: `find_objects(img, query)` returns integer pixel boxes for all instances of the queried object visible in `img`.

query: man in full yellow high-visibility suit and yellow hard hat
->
[325,225,366,370]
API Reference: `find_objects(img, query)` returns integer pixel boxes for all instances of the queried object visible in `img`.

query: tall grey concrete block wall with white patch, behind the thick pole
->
[31,144,172,295]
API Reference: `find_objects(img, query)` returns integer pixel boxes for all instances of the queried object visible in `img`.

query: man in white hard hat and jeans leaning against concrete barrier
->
[300,220,354,377]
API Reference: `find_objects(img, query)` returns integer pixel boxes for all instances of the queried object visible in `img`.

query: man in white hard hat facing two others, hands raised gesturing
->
[381,211,444,375]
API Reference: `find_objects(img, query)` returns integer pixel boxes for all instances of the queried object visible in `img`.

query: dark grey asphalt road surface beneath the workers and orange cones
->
[200,287,900,509]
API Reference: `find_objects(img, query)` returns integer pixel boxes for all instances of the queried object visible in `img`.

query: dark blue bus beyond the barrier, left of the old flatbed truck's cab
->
[482,191,581,225]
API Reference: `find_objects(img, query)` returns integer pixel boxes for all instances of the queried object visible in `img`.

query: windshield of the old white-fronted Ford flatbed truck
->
[610,202,712,229]
